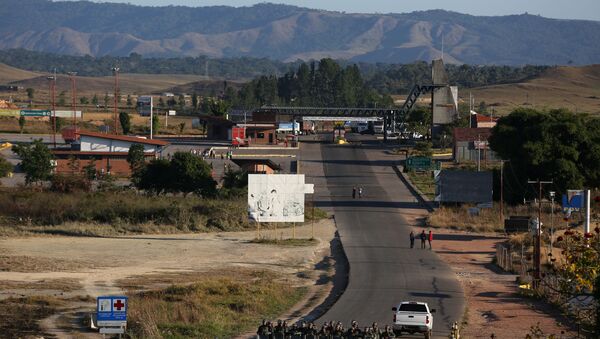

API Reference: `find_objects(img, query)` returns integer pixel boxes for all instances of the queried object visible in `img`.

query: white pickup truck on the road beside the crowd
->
[392,301,435,339]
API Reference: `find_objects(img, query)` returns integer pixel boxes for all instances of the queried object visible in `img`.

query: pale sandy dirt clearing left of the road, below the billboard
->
[0,219,335,338]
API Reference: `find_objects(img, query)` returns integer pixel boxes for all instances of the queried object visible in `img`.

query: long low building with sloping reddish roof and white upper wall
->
[52,131,169,177]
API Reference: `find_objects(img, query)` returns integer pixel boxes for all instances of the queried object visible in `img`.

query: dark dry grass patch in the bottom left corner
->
[0,296,64,338]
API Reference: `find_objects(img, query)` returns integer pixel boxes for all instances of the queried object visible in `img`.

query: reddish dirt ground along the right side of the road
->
[394,205,577,339]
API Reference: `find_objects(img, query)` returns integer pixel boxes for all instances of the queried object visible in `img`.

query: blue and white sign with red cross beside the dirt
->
[96,296,127,334]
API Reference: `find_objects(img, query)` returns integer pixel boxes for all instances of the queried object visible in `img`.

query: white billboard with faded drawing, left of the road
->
[248,174,314,222]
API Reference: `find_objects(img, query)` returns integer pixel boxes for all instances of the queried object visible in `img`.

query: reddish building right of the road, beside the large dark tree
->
[452,128,499,163]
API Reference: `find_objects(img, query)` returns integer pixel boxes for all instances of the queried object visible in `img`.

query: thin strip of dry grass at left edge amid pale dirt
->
[0,255,94,272]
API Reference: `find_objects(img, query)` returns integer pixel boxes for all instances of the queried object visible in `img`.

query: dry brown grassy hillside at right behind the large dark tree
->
[468,65,600,114]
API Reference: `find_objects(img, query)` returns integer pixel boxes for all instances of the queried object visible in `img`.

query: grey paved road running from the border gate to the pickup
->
[303,136,464,338]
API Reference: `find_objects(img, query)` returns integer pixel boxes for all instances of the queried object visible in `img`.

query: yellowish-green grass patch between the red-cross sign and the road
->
[127,271,306,338]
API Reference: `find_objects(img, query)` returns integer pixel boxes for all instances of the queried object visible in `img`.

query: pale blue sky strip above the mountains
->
[75,0,600,21]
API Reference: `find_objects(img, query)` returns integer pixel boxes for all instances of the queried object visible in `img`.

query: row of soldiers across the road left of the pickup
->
[256,320,396,339]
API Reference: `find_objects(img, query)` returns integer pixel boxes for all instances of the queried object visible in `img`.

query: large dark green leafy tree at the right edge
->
[490,109,600,203]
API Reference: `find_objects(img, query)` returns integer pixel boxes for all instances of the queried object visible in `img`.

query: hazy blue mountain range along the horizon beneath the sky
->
[0,0,600,65]
